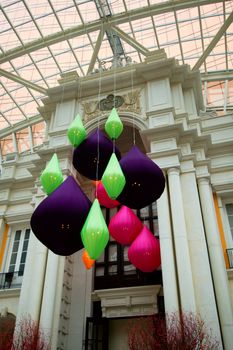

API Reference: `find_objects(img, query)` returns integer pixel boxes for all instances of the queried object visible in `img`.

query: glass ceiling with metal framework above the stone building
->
[0,0,233,158]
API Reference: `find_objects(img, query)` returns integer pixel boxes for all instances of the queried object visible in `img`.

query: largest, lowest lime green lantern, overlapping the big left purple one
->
[81,198,109,260]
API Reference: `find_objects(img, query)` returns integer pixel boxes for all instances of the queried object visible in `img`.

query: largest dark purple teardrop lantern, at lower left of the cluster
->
[31,176,91,255]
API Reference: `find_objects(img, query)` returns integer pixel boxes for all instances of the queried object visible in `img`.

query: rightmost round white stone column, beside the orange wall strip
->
[198,178,233,350]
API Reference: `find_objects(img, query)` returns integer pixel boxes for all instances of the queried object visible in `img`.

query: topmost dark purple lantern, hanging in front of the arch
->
[73,129,120,180]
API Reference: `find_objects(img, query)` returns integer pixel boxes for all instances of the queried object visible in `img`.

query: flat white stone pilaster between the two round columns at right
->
[181,168,222,349]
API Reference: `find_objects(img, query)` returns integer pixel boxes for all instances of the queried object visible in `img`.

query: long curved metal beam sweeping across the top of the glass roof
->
[0,0,226,63]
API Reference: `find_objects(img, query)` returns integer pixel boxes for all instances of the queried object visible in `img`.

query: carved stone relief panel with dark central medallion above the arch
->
[82,89,141,122]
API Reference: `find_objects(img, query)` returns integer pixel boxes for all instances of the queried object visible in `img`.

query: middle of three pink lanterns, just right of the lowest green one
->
[108,205,143,244]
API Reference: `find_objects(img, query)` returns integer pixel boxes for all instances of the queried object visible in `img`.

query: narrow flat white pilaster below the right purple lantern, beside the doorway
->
[157,180,179,314]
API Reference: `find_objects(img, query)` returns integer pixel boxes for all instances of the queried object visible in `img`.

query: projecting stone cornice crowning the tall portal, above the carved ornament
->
[38,53,203,119]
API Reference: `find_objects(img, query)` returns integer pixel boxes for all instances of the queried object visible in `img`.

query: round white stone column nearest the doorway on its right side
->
[168,168,196,312]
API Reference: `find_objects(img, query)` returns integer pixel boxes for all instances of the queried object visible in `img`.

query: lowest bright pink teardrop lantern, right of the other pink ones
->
[128,226,161,272]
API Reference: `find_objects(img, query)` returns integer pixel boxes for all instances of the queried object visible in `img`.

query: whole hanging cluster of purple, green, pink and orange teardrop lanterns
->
[31,108,165,272]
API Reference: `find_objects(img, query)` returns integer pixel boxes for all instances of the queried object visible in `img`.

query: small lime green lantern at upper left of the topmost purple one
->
[67,114,87,147]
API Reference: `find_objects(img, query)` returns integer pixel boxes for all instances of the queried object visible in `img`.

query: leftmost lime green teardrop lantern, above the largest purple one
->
[40,153,63,194]
